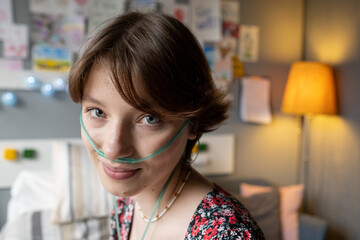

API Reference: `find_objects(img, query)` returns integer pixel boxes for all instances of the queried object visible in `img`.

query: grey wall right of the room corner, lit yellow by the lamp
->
[305,0,360,240]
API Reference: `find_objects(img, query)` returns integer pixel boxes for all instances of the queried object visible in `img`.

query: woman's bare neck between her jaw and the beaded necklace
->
[134,165,187,218]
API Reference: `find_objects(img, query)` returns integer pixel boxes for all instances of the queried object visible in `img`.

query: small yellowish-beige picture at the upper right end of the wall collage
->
[239,25,259,62]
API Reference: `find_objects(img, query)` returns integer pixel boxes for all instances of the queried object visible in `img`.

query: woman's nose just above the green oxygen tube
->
[101,123,134,160]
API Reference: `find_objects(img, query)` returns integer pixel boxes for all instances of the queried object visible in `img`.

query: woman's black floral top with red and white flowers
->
[110,186,265,240]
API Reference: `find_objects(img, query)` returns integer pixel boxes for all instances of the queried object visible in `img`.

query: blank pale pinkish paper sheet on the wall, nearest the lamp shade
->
[239,76,272,124]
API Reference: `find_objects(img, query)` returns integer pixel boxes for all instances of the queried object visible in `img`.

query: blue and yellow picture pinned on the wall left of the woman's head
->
[32,45,71,73]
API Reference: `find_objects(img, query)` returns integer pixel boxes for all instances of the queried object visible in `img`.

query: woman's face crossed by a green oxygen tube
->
[81,65,195,197]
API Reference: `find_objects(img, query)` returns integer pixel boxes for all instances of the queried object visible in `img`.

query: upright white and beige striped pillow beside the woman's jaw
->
[52,142,112,223]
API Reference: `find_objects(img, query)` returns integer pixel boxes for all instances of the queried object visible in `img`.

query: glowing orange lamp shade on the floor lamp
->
[281,62,337,115]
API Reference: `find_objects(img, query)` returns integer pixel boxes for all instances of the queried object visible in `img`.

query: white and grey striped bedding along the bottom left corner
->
[0,210,110,240]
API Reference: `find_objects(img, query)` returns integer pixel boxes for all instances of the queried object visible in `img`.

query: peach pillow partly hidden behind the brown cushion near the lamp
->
[240,183,304,240]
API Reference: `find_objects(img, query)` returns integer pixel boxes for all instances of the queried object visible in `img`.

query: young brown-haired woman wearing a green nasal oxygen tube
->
[69,12,264,240]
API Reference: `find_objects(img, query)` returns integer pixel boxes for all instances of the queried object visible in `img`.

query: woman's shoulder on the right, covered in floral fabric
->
[186,186,264,239]
